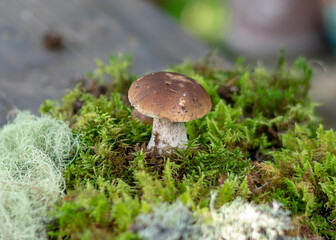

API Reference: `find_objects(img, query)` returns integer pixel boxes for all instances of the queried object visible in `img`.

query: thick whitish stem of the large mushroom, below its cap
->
[147,118,188,152]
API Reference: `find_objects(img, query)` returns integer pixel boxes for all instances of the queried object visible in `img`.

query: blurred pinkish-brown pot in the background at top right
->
[226,0,325,58]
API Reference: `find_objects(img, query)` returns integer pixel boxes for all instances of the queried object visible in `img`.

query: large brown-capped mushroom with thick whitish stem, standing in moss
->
[128,72,211,153]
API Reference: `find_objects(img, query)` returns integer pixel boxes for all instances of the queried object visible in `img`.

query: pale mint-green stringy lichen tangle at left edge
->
[0,112,76,240]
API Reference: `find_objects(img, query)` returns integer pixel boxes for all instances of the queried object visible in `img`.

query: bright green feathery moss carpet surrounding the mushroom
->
[41,53,336,239]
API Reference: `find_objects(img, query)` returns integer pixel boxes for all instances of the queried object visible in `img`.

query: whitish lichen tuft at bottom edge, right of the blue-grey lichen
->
[210,193,300,240]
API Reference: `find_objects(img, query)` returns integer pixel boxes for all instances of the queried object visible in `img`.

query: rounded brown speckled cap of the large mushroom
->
[128,72,211,122]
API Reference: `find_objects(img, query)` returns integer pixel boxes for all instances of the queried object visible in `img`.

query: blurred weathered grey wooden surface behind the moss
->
[0,0,226,125]
